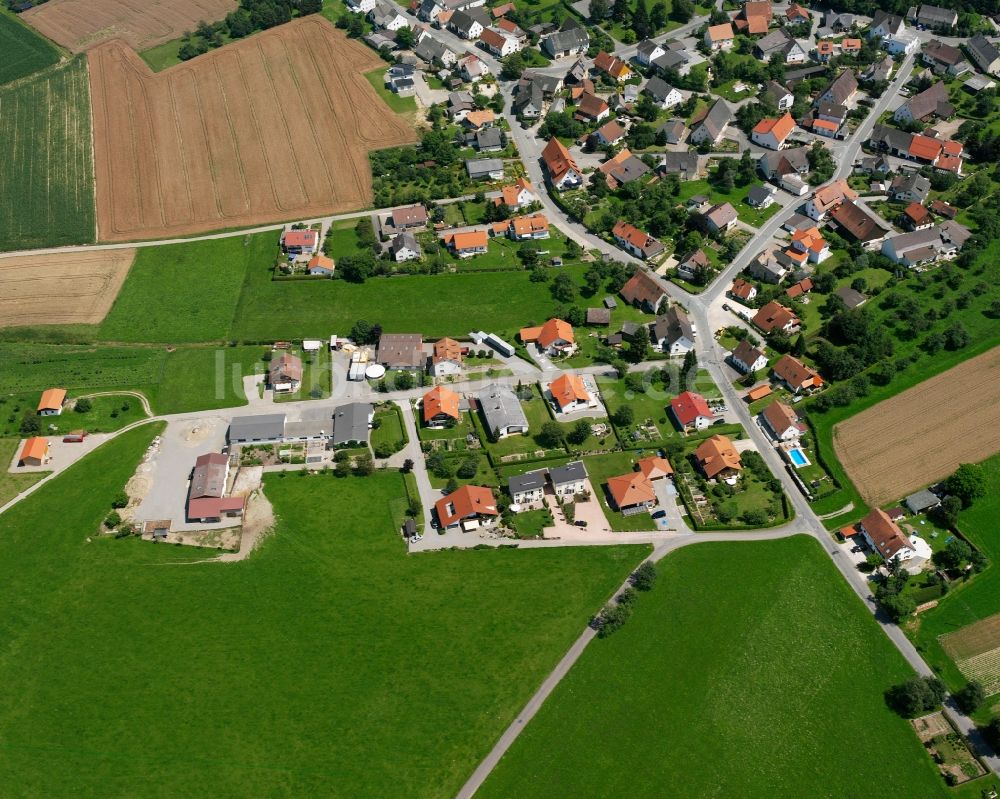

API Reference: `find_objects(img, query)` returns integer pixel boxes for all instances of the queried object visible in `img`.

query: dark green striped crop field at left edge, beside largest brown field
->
[0,55,95,250]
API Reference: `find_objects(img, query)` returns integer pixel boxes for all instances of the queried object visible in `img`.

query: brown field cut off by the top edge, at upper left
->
[21,0,237,53]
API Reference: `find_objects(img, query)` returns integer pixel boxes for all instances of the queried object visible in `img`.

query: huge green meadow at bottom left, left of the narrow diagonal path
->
[0,426,649,797]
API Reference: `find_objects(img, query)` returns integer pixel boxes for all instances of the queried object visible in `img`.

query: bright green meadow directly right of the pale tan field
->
[98,233,272,342]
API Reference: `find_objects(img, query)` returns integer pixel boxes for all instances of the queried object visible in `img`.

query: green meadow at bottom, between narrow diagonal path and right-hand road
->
[477,537,952,799]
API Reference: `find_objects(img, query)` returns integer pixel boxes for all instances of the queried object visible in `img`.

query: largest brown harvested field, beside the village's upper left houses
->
[89,15,416,241]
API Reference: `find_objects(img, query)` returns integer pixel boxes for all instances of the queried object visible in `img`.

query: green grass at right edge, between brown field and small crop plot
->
[910,455,1000,690]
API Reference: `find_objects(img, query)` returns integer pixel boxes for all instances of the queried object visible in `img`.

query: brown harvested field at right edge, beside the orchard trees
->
[833,347,1000,506]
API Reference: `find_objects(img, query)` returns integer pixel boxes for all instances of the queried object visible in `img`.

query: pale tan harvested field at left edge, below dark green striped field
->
[0,249,135,327]
